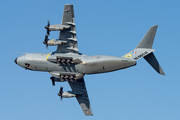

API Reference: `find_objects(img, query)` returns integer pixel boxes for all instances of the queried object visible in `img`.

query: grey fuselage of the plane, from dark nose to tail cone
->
[15,53,136,75]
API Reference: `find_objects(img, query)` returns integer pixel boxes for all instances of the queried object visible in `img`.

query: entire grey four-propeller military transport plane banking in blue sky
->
[15,4,165,116]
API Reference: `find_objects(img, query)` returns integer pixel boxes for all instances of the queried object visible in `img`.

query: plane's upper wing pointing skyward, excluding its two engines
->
[56,5,78,53]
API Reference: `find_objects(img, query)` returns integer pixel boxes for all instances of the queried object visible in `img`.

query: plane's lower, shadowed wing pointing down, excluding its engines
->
[68,78,93,116]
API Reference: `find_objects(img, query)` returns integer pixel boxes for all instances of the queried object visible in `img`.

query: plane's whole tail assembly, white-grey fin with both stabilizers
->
[123,25,165,75]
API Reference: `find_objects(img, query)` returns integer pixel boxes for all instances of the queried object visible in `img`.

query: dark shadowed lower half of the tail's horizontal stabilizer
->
[144,53,165,75]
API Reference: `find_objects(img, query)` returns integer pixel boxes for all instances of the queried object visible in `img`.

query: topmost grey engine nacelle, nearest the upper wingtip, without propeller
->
[49,24,70,31]
